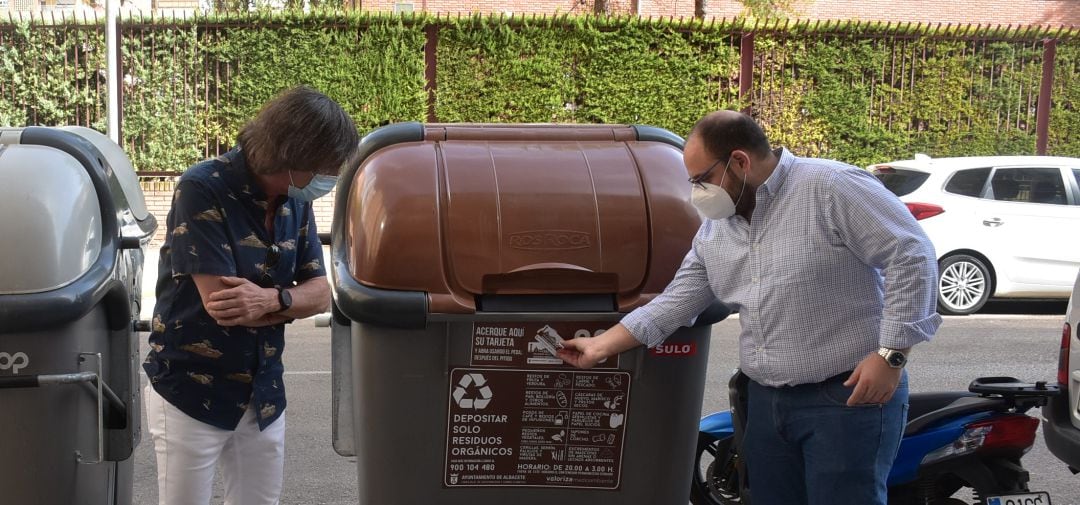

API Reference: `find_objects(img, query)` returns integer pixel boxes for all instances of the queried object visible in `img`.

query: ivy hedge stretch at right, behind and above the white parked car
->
[757,35,1049,165]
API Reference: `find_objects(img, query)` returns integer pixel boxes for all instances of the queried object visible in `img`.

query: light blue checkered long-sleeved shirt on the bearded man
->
[622,149,941,386]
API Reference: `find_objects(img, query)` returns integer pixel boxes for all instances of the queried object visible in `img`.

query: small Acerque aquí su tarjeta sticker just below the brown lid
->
[470,322,619,368]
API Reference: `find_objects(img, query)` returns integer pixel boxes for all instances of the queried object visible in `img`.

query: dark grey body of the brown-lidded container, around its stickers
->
[333,313,711,505]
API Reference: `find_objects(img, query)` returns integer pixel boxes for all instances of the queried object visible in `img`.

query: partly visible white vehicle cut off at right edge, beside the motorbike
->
[1042,269,1080,472]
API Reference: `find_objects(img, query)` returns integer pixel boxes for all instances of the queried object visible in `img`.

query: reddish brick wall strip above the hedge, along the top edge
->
[355,0,1080,26]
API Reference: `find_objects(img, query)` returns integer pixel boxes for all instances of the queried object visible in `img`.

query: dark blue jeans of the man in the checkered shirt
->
[742,371,907,505]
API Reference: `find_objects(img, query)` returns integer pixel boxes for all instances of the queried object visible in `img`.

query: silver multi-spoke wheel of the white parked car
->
[937,255,990,315]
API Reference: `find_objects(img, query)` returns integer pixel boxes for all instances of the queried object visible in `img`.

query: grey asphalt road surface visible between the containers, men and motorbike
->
[134,250,1080,505]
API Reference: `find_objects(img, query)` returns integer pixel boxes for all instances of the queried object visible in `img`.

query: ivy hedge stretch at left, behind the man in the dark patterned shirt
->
[0,13,427,172]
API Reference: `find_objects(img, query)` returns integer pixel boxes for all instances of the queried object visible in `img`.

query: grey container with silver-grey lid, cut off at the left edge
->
[0,126,157,505]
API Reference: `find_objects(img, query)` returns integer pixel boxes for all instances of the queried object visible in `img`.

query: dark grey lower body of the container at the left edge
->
[0,308,139,505]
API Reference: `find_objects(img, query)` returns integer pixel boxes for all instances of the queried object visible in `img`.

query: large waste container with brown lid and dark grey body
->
[332,123,726,505]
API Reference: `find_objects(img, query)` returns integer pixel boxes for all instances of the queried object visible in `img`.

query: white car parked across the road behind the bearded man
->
[868,154,1080,314]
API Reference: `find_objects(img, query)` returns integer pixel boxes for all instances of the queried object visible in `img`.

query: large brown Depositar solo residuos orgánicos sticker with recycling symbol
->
[443,368,630,490]
